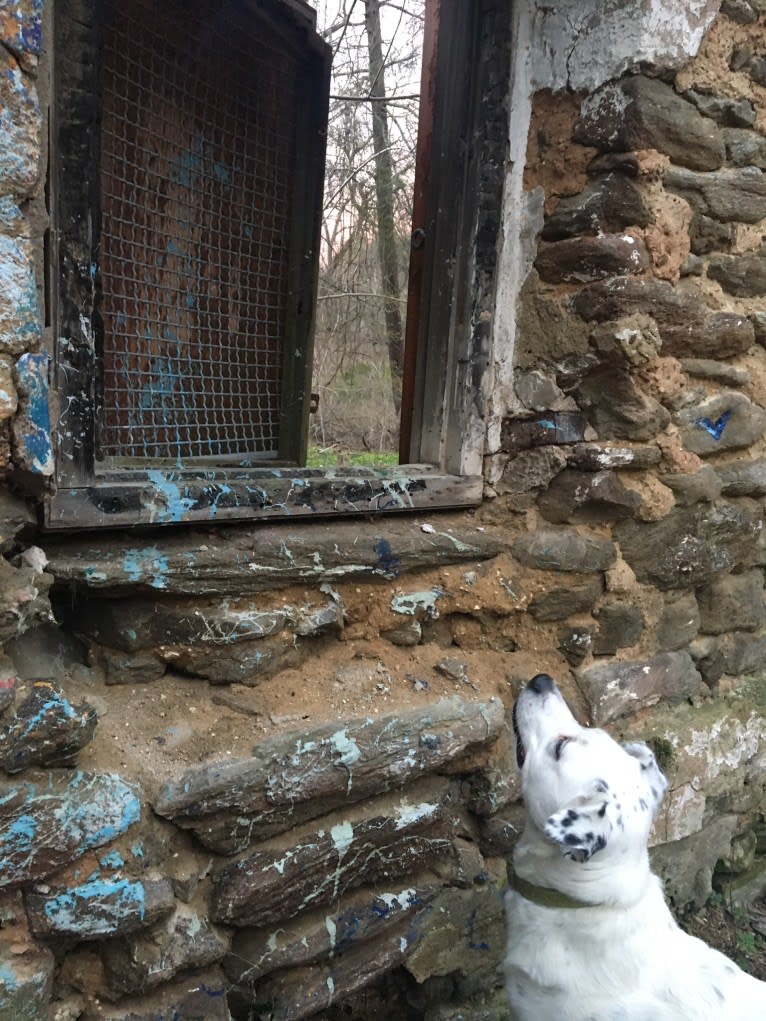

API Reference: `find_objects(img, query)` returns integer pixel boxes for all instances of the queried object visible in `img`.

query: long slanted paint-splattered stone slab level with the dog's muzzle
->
[154,697,505,854]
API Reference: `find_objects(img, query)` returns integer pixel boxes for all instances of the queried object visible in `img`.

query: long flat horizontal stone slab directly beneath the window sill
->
[45,516,511,596]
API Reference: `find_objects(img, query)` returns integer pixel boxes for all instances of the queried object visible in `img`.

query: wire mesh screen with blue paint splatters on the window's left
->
[98,0,299,463]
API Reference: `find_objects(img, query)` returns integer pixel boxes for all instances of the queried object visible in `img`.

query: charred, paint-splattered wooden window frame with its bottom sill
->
[43,0,494,530]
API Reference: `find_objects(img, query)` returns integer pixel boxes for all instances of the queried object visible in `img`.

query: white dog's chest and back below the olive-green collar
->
[506,891,766,1021]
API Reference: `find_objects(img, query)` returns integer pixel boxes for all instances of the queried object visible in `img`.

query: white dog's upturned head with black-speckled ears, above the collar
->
[513,674,668,862]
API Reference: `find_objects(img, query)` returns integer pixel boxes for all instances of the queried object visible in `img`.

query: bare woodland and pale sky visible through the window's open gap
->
[312,0,424,453]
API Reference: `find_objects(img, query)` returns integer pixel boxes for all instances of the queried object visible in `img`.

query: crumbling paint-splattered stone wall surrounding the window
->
[0,0,766,1021]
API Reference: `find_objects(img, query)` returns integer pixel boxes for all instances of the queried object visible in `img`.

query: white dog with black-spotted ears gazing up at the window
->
[505,674,766,1021]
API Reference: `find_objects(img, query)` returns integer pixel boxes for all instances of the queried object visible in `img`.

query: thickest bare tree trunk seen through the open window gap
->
[365,0,403,415]
